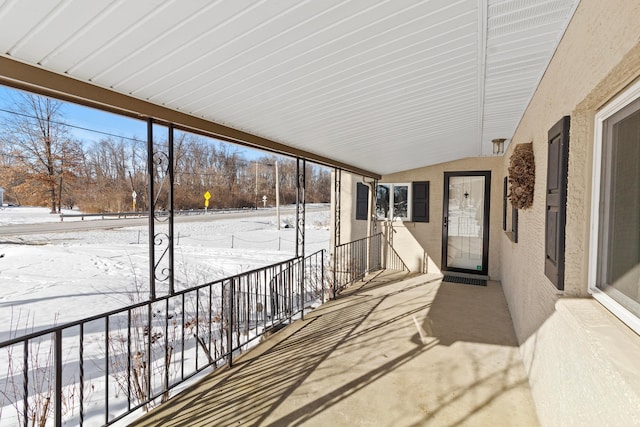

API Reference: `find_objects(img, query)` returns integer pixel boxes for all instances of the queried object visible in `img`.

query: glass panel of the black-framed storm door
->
[446,176,485,271]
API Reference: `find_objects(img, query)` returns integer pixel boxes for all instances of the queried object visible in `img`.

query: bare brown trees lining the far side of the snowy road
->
[0,94,330,213]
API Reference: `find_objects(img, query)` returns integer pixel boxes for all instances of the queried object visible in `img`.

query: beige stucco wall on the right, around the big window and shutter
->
[500,0,640,425]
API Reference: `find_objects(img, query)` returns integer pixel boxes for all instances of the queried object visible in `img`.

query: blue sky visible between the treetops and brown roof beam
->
[0,85,269,160]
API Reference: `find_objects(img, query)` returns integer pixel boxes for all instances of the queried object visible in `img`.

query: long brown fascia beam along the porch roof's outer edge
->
[0,56,380,179]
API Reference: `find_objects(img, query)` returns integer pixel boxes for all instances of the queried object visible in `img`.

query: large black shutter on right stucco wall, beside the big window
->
[544,116,570,290]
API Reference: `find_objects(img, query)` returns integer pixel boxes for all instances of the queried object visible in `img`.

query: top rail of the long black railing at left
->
[0,249,324,348]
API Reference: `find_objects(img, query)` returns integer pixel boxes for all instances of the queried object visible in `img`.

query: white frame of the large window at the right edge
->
[588,81,640,334]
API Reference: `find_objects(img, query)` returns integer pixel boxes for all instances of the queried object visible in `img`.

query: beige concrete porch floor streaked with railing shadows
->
[135,272,538,427]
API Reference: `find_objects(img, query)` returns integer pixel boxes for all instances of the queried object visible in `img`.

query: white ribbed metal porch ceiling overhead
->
[0,0,579,174]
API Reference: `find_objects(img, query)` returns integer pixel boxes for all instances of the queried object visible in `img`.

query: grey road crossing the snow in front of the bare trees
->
[0,206,329,236]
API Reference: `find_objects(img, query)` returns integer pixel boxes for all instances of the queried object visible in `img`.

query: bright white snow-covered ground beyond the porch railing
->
[0,206,330,426]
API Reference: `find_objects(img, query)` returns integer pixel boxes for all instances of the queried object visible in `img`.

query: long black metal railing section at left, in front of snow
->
[0,251,331,427]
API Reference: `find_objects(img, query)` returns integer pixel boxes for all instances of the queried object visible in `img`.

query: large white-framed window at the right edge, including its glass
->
[589,83,640,333]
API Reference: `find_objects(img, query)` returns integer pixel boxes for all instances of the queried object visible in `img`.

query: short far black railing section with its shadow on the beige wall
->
[332,233,409,297]
